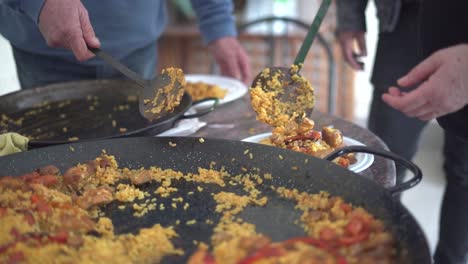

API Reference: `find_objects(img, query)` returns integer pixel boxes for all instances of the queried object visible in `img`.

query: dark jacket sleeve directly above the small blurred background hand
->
[336,0,368,32]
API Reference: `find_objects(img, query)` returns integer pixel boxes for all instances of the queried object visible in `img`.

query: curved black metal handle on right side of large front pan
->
[325,146,422,195]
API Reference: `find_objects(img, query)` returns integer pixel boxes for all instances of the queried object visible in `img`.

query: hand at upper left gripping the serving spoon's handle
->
[39,0,100,61]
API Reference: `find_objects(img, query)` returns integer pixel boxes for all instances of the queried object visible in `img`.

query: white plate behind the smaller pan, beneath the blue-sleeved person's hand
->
[185,74,248,110]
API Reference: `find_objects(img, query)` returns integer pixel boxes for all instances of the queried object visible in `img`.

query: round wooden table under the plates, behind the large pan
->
[193,95,396,187]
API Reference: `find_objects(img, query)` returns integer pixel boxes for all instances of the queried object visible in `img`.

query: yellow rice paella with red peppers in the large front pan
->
[0,152,397,264]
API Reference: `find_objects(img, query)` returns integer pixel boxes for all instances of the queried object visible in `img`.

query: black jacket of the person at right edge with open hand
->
[421,0,468,140]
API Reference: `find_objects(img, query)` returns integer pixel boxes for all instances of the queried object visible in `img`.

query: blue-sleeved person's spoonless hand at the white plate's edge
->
[208,37,251,84]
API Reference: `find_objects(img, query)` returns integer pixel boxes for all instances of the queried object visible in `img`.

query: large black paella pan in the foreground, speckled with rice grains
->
[0,138,430,263]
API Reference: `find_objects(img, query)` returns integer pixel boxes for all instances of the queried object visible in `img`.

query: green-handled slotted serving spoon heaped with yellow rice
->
[251,0,331,126]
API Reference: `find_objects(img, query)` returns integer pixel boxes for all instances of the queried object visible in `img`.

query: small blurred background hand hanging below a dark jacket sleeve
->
[338,31,367,70]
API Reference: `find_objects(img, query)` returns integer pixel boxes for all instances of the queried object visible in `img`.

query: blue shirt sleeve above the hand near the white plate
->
[191,0,237,45]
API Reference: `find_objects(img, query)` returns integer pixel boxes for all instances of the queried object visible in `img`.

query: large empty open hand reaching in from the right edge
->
[382,45,468,121]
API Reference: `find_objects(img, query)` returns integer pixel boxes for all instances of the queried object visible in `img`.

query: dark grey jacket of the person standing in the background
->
[337,0,402,32]
